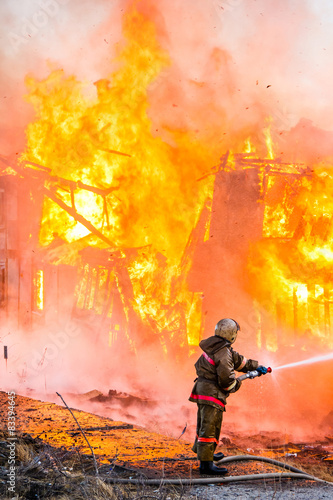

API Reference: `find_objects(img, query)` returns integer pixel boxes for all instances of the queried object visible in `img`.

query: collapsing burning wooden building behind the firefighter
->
[1,145,331,360]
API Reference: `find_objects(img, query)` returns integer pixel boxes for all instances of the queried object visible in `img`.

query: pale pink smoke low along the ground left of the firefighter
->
[0,322,195,437]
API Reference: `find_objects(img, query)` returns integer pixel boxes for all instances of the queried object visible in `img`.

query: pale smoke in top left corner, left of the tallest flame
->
[0,0,123,156]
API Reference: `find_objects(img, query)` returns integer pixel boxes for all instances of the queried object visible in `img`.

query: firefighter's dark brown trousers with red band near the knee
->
[192,404,223,462]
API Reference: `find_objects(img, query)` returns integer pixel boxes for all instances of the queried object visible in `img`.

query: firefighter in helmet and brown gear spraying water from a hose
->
[189,318,267,475]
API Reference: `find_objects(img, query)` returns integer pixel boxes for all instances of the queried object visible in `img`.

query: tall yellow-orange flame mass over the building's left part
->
[18,8,213,352]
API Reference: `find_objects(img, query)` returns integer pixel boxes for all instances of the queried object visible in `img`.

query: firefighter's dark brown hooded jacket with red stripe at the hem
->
[189,336,258,411]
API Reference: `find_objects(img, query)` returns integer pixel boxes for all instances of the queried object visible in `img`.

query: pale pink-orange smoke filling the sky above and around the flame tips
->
[0,0,333,153]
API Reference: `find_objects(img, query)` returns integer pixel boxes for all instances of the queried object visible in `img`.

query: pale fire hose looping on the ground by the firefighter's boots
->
[104,455,333,486]
